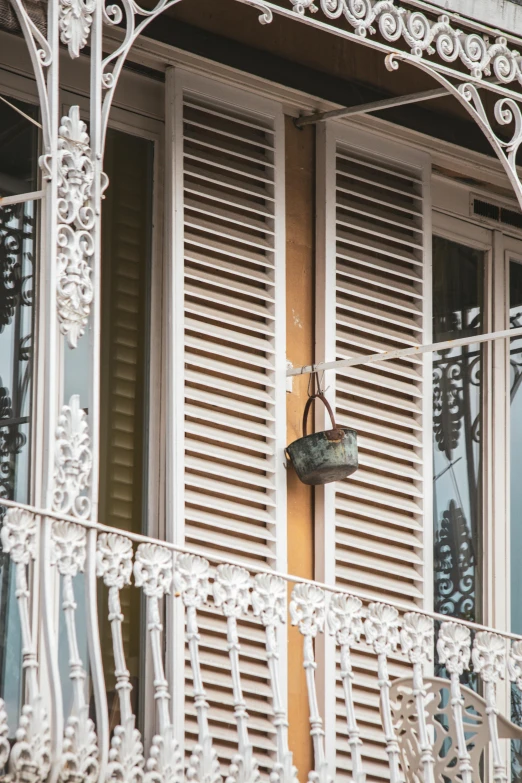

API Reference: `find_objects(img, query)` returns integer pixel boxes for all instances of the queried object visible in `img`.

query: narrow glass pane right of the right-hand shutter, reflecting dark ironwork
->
[433,237,485,622]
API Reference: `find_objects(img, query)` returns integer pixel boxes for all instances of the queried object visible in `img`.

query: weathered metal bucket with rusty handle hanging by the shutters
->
[286,393,359,484]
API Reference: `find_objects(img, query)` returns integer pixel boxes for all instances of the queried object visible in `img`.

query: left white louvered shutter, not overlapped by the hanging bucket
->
[168,75,286,772]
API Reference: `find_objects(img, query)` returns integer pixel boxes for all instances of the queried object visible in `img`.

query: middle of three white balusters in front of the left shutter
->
[212,565,261,783]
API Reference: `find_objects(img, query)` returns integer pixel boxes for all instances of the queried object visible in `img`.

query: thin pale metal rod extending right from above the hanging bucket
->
[286,327,522,377]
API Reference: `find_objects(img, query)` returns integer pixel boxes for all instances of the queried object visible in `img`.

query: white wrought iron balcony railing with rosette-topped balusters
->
[0,501,522,783]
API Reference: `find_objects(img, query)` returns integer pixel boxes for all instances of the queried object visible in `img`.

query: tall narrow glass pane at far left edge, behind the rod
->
[0,98,38,738]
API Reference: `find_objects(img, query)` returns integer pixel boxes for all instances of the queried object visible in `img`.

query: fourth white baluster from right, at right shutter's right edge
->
[400,612,435,783]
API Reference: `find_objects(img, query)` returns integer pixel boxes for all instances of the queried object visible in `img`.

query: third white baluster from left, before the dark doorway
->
[96,533,145,783]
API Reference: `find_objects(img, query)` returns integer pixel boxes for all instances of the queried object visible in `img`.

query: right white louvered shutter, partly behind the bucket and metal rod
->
[319,128,431,780]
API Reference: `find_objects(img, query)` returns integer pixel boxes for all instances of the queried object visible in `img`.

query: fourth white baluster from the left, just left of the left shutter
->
[134,544,183,783]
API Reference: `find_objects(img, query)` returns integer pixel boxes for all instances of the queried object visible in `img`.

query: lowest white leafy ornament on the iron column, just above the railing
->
[53,394,92,517]
